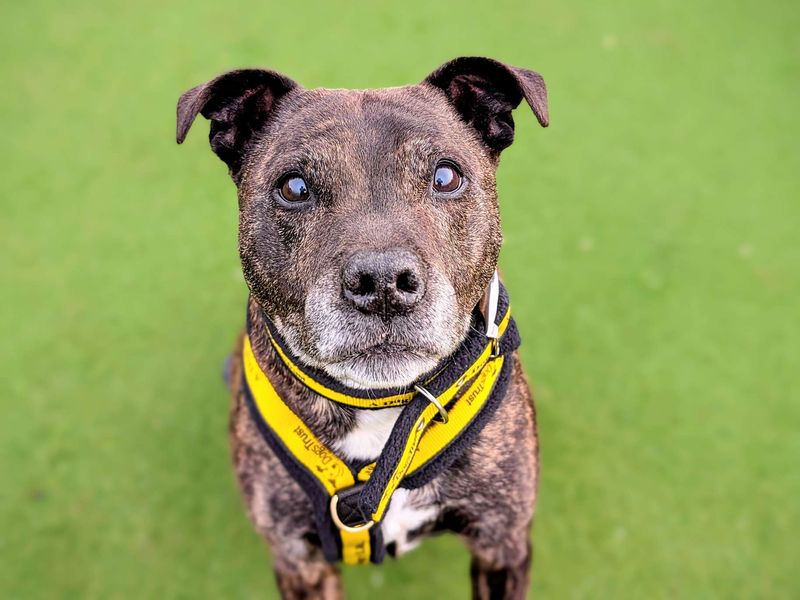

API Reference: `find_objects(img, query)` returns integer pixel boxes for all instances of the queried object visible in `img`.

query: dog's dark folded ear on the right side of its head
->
[425,56,548,152]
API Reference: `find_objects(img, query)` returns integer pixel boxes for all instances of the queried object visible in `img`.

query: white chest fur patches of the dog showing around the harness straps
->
[333,407,438,554]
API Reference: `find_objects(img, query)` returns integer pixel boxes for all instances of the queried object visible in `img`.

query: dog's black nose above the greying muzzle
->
[342,248,432,319]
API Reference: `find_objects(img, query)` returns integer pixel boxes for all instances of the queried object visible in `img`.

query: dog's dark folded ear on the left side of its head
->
[176,69,299,179]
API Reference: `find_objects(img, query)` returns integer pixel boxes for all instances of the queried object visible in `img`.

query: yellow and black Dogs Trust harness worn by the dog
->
[242,274,518,564]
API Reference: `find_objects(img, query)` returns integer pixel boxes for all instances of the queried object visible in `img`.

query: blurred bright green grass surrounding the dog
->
[0,0,800,600]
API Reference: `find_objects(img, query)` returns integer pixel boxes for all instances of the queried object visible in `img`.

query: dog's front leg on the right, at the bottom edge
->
[468,528,532,600]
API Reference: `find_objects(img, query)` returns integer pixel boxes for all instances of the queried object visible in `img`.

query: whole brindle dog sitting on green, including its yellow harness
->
[177,57,548,598]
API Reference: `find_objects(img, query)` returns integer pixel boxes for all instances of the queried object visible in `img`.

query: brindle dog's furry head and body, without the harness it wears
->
[177,57,548,598]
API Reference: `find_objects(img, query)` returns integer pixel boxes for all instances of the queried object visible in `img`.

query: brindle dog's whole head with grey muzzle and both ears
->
[178,58,547,388]
